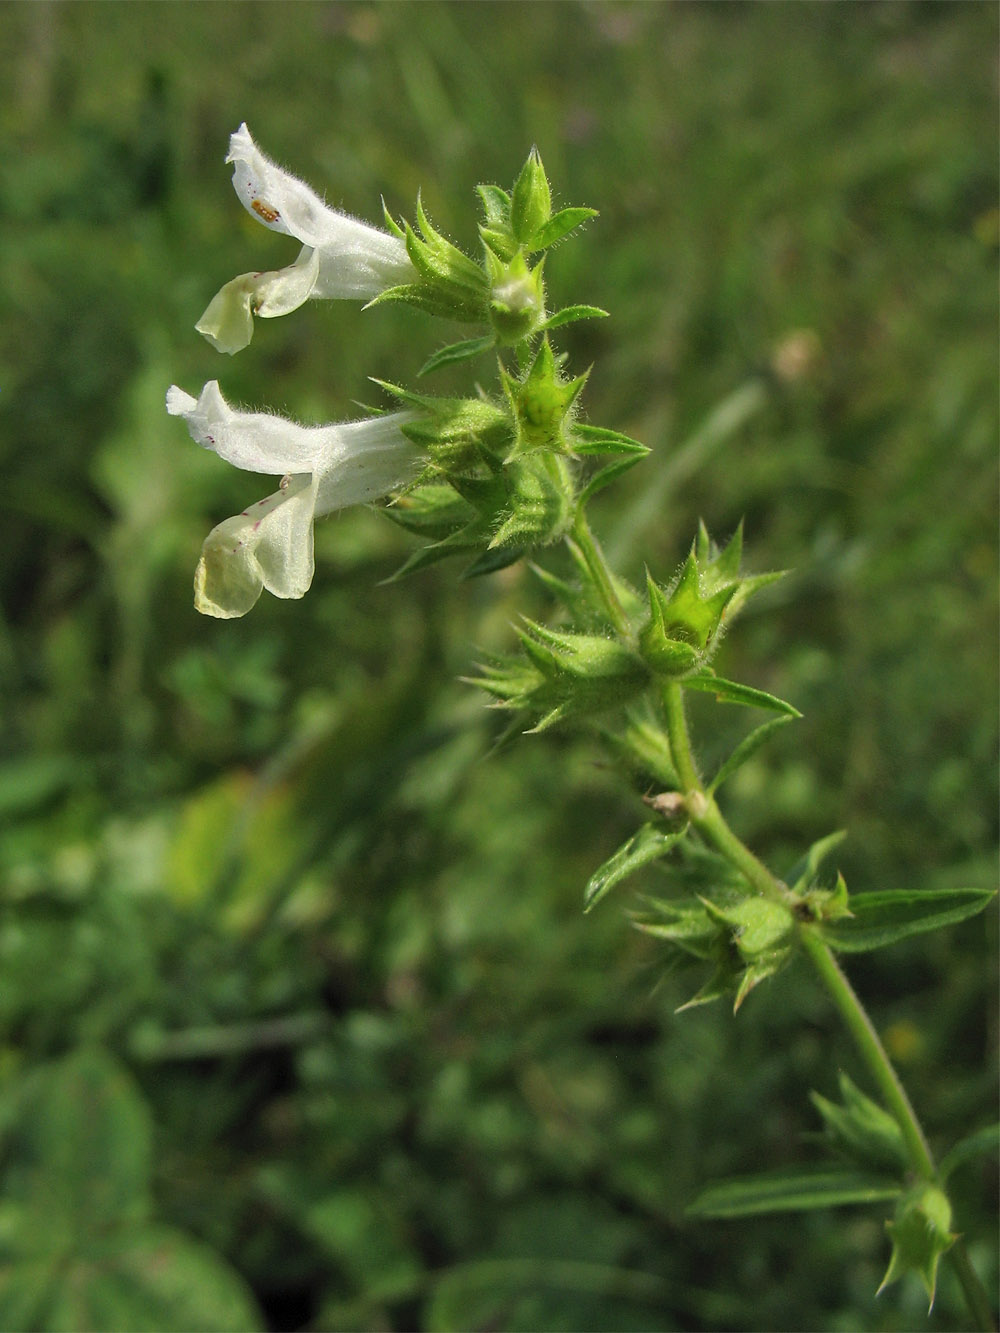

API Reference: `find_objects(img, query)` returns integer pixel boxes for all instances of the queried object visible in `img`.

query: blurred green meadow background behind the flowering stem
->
[0,0,997,1330]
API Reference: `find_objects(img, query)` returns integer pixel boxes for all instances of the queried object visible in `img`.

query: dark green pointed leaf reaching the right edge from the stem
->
[820,889,996,953]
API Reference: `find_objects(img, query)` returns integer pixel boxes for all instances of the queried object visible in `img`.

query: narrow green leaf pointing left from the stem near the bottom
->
[685,1168,903,1217]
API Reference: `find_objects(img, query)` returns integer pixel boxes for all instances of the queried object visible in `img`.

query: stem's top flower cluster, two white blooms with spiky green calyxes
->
[167,124,602,619]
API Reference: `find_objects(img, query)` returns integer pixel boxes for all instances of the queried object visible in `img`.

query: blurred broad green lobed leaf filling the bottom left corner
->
[0,1049,261,1333]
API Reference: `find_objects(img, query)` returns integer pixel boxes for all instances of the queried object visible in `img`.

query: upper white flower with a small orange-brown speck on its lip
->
[195,124,417,353]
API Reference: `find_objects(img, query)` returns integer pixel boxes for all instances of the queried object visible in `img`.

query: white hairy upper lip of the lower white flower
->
[167,380,326,476]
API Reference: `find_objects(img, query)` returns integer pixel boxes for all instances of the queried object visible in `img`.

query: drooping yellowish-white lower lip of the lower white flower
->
[195,476,316,620]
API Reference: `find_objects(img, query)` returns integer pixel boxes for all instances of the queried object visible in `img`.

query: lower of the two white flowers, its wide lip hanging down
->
[167,380,421,620]
